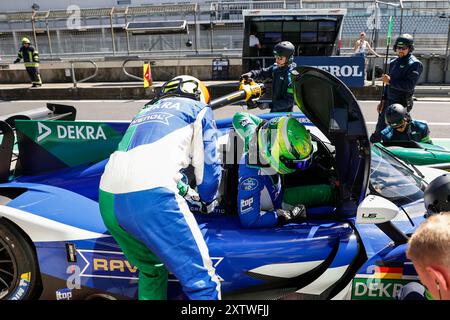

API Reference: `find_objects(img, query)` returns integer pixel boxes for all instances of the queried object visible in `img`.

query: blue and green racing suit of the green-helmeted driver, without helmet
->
[233,112,335,228]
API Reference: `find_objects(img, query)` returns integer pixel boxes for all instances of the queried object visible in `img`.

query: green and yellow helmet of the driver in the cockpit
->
[258,117,313,174]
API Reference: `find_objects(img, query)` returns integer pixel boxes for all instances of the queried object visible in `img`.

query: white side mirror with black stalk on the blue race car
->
[356,195,409,245]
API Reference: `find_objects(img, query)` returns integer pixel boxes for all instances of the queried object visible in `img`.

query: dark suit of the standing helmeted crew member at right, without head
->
[370,54,423,143]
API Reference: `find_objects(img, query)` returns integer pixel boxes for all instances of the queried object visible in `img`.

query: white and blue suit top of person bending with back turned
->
[101,98,221,203]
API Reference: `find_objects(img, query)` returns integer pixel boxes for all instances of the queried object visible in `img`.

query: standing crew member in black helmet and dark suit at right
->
[370,33,423,143]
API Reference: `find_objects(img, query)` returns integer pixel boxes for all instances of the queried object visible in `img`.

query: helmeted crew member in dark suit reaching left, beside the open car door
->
[241,41,297,112]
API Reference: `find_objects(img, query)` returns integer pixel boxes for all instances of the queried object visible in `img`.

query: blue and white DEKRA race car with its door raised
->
[0,67,440,300]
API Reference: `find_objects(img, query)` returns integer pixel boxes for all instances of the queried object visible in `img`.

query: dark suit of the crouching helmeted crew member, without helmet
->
[381,120,432,143]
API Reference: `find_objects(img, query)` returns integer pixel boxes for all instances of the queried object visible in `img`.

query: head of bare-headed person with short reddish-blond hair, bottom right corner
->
[407,212,450,300]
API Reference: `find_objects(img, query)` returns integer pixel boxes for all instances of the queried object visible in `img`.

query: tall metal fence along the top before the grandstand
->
[0,1,450,61]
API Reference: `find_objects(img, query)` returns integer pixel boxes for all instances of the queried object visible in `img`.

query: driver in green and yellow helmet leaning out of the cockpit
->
[233,112,333,228]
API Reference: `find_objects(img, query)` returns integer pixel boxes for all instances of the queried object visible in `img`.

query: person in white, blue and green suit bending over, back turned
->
[99,76,222,300]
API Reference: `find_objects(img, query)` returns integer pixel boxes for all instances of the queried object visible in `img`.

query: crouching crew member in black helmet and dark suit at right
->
[381,103,432,143]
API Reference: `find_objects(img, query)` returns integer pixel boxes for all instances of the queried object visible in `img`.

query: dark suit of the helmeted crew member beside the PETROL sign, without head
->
[249,63,297,112]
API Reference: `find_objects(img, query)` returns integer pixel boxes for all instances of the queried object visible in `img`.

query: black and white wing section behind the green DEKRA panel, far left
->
[0,103,77,183]
